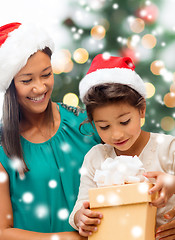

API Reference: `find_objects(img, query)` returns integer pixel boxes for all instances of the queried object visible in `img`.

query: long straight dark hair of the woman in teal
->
[1,47,53,172]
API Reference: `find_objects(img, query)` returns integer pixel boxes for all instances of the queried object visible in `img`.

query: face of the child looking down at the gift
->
[93,103,146,155]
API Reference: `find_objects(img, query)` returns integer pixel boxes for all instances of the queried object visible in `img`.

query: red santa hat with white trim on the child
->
[79,54,146,101]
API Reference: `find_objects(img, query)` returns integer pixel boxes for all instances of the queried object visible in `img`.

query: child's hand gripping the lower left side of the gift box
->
[74,202,103,237]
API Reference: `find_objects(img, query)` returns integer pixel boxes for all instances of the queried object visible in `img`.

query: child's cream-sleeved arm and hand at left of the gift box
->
[69,145,104,237]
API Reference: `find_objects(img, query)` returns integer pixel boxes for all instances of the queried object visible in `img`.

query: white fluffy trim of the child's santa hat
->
[79,68,146,101]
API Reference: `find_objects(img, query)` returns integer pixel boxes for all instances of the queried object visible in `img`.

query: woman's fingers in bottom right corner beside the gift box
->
[156,208,175,240]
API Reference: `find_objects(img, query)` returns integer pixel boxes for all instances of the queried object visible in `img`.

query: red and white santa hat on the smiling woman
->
[0,22,54,92]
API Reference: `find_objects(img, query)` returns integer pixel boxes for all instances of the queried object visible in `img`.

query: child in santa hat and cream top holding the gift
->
[70,55,175,239]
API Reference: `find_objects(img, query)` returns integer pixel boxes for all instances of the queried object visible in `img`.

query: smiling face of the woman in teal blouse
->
[14,51,54,113]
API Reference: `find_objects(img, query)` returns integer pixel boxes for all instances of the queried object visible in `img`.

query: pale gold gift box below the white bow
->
[88,182,157,240]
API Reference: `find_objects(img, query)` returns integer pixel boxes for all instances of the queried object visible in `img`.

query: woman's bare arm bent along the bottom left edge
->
[0,163,86,240]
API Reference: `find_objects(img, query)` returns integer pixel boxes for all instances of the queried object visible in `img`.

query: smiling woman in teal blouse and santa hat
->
[0,23,100,240]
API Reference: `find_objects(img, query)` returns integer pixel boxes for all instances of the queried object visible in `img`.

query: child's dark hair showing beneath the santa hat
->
[81,83,146,126]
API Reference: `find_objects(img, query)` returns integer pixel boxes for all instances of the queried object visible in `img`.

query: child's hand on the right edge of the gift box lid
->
[143,172,175,208]
